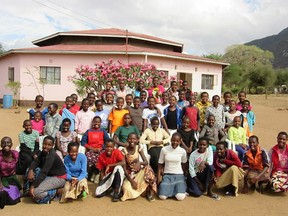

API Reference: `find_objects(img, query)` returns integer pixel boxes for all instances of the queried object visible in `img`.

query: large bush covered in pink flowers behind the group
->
[68,60,176,95]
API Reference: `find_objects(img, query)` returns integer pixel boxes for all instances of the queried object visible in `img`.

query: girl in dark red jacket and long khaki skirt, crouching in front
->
[213,141,245,196]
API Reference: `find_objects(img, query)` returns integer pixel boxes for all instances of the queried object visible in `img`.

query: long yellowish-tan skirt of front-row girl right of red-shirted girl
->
[121,165,157,201]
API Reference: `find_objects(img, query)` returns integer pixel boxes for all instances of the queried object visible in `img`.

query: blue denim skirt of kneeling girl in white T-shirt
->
[158,174,187,197]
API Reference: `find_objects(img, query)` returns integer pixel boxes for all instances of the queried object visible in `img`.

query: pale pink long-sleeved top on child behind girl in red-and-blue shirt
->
[75,110,95,134]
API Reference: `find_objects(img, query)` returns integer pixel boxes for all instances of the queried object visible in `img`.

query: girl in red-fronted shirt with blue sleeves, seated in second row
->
[81,116,109,183]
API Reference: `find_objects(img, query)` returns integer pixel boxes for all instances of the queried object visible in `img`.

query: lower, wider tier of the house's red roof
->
[10,44,228,65]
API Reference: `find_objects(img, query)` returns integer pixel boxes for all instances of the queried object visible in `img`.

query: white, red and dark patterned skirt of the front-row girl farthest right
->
[270,171,288,192]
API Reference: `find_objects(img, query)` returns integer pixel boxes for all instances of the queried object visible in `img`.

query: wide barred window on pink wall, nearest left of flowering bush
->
[40,66,61,85]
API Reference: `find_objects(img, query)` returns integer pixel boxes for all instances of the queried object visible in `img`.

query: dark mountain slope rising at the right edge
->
[245,28,288,68]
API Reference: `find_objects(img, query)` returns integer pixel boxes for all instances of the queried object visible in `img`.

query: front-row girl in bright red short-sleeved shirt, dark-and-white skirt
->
[95,139,125,202]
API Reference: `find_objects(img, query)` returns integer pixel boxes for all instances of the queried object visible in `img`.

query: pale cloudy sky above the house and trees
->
[0,0,288,55]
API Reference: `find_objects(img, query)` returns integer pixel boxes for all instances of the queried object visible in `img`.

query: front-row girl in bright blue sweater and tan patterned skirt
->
[60,142,89,202]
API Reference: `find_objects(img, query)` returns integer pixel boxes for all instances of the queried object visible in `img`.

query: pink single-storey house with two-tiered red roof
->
[0,28,228,105]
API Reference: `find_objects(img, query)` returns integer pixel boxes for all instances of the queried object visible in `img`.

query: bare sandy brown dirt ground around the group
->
[0,95,288,216]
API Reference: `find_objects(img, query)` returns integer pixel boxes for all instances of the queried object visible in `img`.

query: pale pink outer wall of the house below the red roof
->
[0,54,222,101]
